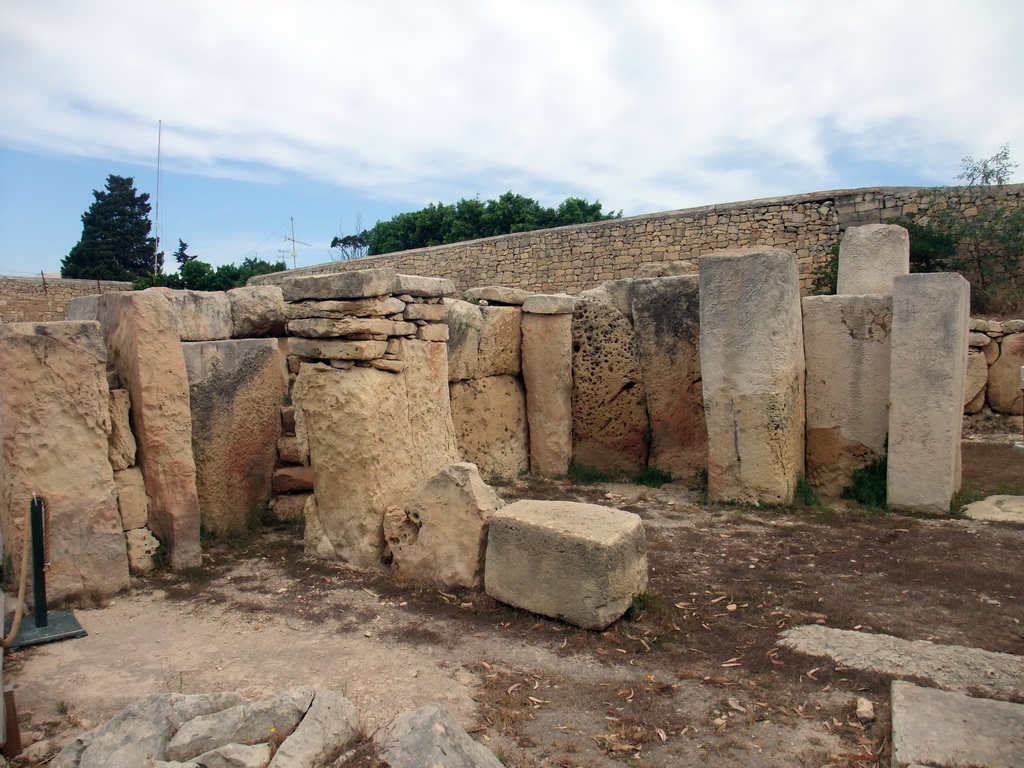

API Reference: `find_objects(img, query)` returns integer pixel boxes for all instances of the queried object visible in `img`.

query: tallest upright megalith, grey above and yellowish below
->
[699,248,805,504]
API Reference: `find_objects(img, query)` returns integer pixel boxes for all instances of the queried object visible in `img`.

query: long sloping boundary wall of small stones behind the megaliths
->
[249,184,1024,294]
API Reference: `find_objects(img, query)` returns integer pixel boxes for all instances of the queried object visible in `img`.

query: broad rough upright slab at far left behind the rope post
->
[0,321,132,600]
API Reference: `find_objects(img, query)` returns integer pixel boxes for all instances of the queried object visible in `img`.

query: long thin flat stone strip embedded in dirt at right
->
[777,625,1024,698]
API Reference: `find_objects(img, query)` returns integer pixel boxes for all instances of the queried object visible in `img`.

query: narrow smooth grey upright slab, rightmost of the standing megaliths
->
[888,272,971,514]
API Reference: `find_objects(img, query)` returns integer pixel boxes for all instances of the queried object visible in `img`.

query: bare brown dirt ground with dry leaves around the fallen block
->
[6,417,1024,768]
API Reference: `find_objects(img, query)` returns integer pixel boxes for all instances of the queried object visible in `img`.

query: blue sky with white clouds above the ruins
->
[0,0,1024,275]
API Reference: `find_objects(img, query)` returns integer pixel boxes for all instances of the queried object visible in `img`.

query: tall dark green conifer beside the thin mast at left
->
[60,174,163,281]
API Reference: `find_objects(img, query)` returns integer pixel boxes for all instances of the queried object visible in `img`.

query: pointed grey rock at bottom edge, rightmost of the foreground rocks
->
[374,703,502,768]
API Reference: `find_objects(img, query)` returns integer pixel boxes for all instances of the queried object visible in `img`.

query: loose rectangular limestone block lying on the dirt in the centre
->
[484,500,647,630]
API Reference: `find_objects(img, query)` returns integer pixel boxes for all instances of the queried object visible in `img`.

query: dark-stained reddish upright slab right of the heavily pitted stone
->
[630,274,708,483]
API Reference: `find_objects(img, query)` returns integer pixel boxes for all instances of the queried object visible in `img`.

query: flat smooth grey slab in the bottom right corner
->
[892,680,1024,768]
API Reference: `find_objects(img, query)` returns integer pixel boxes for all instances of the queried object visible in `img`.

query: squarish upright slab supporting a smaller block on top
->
[803,294,892,498]
